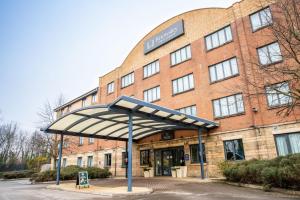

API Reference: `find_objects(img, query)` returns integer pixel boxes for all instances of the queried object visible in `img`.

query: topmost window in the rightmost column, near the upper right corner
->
[250,7,272,31]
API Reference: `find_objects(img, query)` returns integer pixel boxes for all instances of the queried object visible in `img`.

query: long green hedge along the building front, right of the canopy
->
[219,154,300,190]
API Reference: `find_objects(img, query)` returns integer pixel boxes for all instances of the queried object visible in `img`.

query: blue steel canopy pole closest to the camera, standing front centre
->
[127,112,132,192]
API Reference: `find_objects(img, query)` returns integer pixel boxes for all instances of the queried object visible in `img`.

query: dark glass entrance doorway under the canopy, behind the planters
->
[154,146,185,176]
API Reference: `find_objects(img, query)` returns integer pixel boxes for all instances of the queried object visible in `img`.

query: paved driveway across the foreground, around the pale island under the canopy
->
[0,178,300,200]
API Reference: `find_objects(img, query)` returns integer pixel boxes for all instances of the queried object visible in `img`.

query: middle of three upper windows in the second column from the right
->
[209,58,239,83]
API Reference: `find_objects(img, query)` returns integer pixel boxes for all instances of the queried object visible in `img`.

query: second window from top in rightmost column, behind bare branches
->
[257,42,282,65]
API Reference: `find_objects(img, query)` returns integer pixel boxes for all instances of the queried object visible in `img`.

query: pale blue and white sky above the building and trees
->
[0,0,238,132]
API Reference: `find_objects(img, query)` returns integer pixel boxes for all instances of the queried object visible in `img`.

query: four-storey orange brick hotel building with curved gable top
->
[55,0,300,177]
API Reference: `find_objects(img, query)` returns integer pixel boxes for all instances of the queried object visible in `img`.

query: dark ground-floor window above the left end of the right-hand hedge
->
[224,139,245,160]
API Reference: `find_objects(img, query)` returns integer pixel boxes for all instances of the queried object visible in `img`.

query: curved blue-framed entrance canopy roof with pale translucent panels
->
[43,96,218,141]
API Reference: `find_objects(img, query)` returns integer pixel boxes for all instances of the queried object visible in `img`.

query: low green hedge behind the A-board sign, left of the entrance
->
[31,165,111,182]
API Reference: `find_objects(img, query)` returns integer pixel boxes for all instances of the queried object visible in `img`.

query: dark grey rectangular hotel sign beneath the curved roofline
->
[144,20,184,54]
